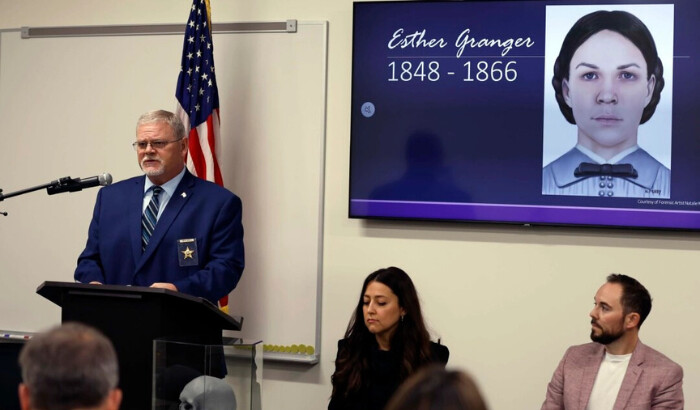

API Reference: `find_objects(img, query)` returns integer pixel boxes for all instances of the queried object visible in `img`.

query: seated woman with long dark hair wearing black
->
[328,267,450,410]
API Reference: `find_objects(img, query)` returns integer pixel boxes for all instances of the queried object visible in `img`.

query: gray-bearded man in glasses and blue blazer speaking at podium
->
[75,110,244,304]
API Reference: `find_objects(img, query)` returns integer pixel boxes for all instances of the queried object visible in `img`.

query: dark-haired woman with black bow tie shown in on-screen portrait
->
[542,11,671,198]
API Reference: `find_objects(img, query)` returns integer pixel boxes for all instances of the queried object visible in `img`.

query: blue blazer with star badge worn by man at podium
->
[75,171,244,303]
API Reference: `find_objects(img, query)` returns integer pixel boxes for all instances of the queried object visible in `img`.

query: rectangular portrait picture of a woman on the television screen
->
[542,4,673,199]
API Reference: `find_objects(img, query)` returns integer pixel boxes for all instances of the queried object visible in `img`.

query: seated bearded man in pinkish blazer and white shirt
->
[542,274,683,410]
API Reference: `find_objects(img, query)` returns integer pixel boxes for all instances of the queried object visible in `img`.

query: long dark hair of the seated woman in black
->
[331,266,431,397]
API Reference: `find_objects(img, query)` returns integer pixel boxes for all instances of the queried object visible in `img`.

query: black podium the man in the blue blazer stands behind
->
[37,282,243,410]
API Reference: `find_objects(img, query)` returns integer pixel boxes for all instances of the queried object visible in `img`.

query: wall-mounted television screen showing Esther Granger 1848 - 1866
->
[349,0,700,229]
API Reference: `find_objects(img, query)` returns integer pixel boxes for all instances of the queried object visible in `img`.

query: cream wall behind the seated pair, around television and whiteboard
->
[0,0,700,410]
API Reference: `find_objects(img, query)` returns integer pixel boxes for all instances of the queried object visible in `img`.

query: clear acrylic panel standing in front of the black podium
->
[152,338,263,410]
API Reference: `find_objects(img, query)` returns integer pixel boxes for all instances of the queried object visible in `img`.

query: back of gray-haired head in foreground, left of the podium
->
[19,322,119,410]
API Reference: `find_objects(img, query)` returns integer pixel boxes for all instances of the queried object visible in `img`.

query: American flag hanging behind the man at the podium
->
[175,0,228,312]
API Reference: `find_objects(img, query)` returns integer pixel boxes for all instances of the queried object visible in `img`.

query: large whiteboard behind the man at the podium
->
[0,22,327,363]
